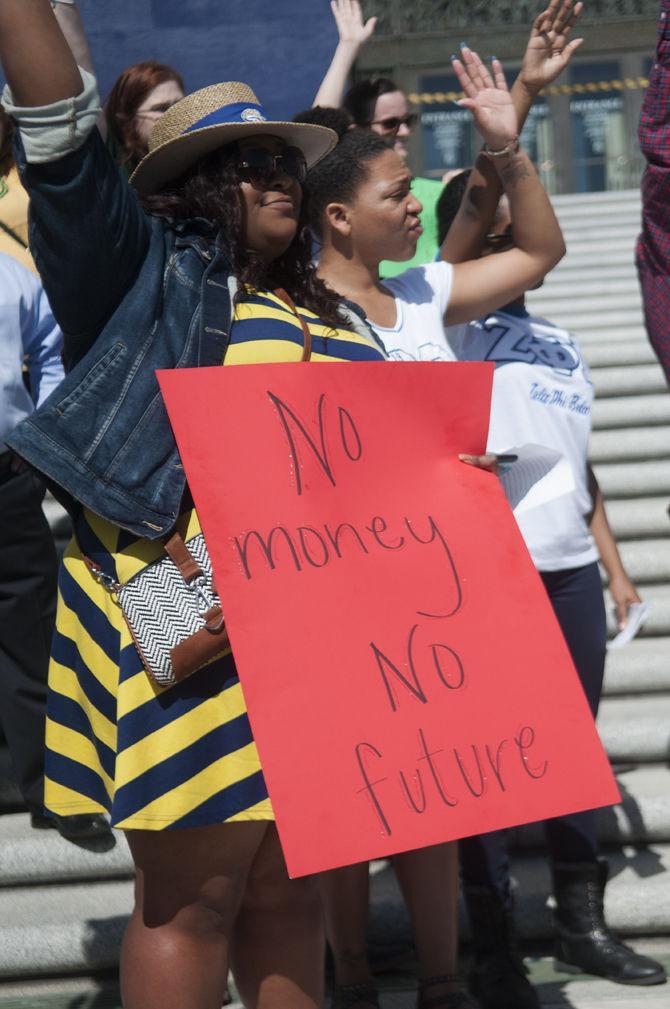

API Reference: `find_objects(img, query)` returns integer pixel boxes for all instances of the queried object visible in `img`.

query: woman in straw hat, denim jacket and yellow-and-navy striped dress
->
[0,0,383,1009]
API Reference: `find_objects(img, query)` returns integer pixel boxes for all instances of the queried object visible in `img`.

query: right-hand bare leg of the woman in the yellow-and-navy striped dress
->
[231,824,325,1009]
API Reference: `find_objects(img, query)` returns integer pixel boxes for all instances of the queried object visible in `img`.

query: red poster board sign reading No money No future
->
[159,362,619,876]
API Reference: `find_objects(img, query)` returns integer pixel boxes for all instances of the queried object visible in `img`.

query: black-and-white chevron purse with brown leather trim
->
[85,533,229,687]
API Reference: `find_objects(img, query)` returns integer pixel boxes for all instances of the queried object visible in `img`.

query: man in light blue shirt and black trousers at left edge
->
[0,253,108,839]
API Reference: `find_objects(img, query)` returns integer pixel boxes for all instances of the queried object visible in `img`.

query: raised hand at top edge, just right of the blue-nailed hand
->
[519,0,584,92]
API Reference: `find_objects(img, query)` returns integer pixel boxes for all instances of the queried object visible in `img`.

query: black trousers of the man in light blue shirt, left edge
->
[0,455,58,811]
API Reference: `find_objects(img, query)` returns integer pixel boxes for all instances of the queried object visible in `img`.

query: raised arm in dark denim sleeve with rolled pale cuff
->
[0,0,150,367]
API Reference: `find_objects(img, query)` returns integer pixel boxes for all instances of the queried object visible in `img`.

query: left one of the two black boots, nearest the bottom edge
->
[463,886,540,1009]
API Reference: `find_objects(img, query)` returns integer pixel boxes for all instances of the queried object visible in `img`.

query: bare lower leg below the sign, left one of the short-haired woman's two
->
[319,862,372,1009]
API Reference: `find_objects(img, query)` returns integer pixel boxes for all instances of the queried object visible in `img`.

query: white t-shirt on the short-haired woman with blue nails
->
[367,262,456,361]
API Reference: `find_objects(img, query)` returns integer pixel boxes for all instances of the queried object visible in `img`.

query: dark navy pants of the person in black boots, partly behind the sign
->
[460,563,607,903]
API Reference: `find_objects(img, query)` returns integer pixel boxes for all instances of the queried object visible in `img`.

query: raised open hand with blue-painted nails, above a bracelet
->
[452,45,519,150]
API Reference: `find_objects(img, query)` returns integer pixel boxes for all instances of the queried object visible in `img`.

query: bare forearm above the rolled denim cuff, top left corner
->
[0,0,84,107]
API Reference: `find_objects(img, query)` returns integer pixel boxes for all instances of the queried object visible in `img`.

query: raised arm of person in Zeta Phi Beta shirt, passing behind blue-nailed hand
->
[440,0,583,262]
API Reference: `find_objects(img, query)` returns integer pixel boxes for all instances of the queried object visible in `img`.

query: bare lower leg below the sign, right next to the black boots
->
[393,843,462,998]
